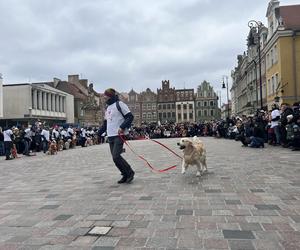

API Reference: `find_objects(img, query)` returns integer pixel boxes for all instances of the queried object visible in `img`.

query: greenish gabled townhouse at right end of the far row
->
[195,81,220,122]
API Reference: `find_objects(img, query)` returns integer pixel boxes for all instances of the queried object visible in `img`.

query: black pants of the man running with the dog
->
[108,136,133,177]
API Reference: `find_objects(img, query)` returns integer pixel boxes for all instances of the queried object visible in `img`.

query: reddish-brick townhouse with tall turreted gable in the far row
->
[157,80,176,124]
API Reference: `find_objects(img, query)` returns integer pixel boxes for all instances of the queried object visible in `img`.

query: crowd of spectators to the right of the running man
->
[129,102,300,151]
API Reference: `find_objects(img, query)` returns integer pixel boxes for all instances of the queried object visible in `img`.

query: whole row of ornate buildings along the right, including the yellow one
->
[231,0,300,115]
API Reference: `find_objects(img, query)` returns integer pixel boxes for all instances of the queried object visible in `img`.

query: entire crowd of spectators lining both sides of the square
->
[0,103,300,160]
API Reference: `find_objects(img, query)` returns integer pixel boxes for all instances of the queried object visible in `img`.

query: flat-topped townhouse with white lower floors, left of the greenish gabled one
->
[175,89,196,123]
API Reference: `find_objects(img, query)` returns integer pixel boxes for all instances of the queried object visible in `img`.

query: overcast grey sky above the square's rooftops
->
[0,0,300,98]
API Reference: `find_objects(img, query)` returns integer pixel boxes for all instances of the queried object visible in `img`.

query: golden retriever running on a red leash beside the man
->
[177,136,207,176]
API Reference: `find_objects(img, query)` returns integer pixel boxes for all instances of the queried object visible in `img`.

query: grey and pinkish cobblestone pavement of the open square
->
[0,138,300,250]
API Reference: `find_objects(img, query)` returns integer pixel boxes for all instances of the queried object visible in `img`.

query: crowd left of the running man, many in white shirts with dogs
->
[0,121,104,160]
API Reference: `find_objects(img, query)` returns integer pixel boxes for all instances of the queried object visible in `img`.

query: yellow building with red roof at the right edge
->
[263,0,300,109]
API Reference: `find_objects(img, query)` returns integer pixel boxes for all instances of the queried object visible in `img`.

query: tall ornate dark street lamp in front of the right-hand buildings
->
[248,20,263,109]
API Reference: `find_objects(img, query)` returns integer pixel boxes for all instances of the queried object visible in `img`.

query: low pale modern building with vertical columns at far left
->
[0,83,74,125]
